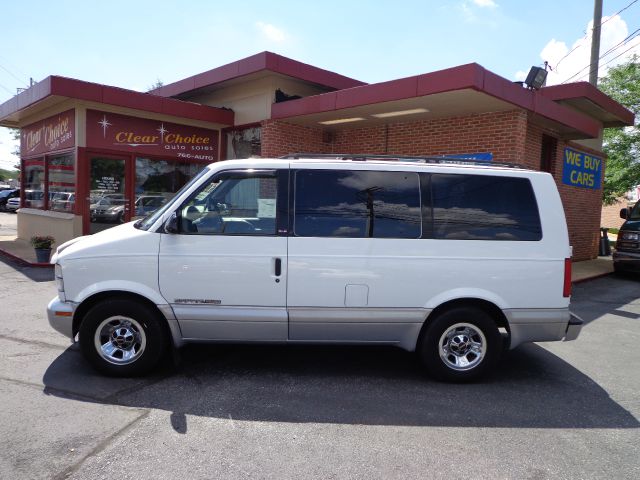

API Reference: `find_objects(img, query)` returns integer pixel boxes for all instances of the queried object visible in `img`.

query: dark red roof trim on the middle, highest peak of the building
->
[153,52,365,97]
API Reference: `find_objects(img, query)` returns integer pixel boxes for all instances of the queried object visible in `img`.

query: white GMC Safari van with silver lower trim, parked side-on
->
[48,155,582,381]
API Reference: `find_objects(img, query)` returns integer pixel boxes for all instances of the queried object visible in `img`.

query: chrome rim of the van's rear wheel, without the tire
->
[438,323,487,371]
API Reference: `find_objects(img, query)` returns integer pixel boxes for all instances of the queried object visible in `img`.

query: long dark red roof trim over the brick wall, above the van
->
[271,63,617,138]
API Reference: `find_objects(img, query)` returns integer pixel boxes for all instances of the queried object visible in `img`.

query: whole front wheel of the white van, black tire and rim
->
[79,298,168,377]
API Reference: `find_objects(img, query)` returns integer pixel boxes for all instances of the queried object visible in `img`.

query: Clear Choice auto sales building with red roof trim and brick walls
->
[0,52,634,260]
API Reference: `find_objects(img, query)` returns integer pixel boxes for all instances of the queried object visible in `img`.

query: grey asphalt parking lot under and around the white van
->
[0,263,640,479]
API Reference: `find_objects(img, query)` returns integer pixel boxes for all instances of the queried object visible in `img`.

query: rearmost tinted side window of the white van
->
[431,174,542,241]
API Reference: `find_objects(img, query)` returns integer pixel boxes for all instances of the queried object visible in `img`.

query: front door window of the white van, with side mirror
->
[180,172,278,235]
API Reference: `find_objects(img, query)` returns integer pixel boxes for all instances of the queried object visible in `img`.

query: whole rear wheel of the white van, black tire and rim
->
[418,307,503,382]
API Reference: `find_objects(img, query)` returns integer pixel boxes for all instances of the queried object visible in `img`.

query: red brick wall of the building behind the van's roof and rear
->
[262,110,604,260]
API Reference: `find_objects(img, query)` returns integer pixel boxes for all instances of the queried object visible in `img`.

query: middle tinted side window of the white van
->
[294,170,422,238]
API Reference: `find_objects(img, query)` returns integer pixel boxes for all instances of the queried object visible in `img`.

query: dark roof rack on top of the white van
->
[280,153,525,169]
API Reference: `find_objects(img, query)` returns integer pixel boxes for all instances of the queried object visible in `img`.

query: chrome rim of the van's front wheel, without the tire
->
[94,315,147,365]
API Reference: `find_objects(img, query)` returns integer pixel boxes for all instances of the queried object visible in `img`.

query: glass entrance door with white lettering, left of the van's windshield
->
[84,154,131,233]
